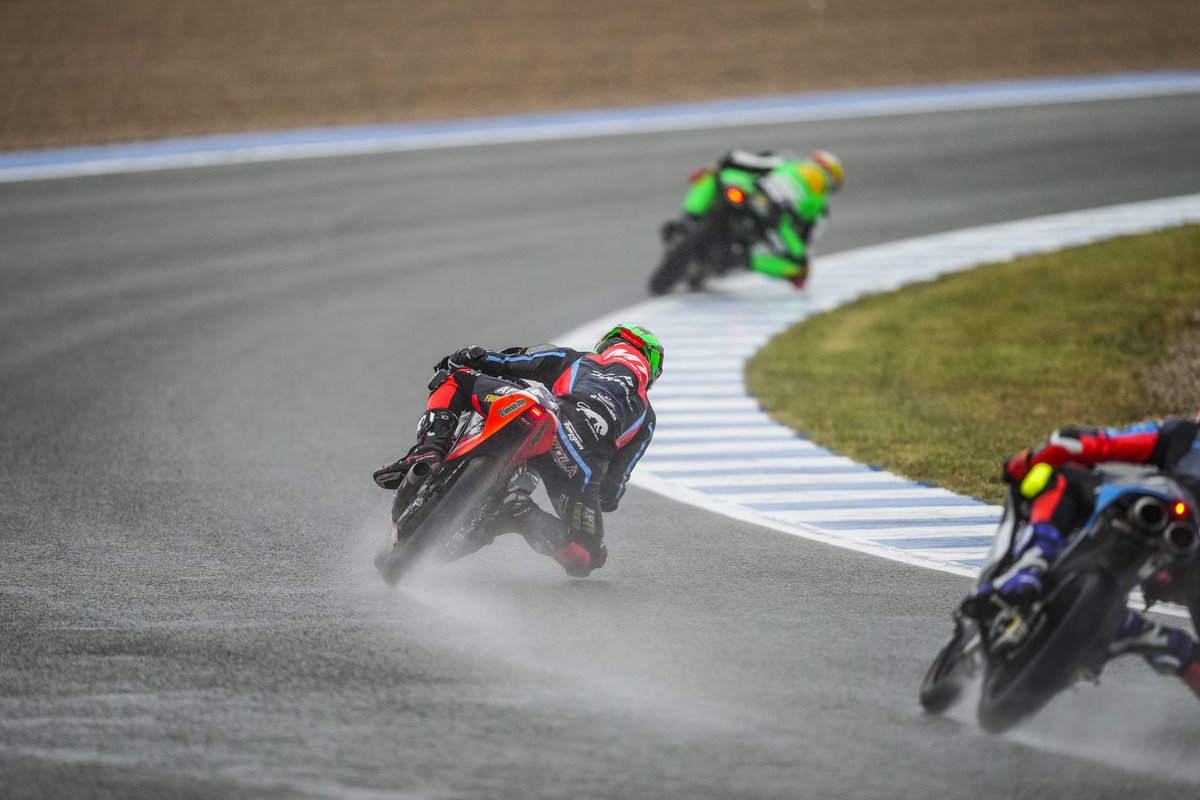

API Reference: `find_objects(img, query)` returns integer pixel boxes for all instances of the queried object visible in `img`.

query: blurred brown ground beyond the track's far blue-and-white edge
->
[0,0,1200,150]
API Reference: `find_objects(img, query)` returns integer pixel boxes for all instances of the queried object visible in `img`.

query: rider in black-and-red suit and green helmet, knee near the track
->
[374,325,662,577]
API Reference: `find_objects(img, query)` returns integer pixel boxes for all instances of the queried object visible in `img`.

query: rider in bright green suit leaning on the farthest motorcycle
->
[683,150,845,289]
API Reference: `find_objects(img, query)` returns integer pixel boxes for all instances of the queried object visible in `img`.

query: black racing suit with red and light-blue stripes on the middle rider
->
[430,343,655,557]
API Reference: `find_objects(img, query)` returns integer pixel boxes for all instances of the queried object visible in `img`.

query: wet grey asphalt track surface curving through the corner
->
[0,96,1200,800]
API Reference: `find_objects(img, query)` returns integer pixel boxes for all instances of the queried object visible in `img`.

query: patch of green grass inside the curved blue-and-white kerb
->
[746,225,1200,503]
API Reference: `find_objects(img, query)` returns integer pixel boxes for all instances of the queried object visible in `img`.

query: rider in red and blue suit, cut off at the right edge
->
[973,414,1200,696]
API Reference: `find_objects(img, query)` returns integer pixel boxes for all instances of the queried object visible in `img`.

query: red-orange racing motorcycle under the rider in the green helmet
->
[374,373,558,585]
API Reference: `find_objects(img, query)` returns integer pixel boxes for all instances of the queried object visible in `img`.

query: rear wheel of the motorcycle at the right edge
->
[977,572,1124,733]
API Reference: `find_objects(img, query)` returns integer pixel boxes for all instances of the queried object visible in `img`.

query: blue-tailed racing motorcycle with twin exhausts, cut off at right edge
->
[920,470,1200,733]
